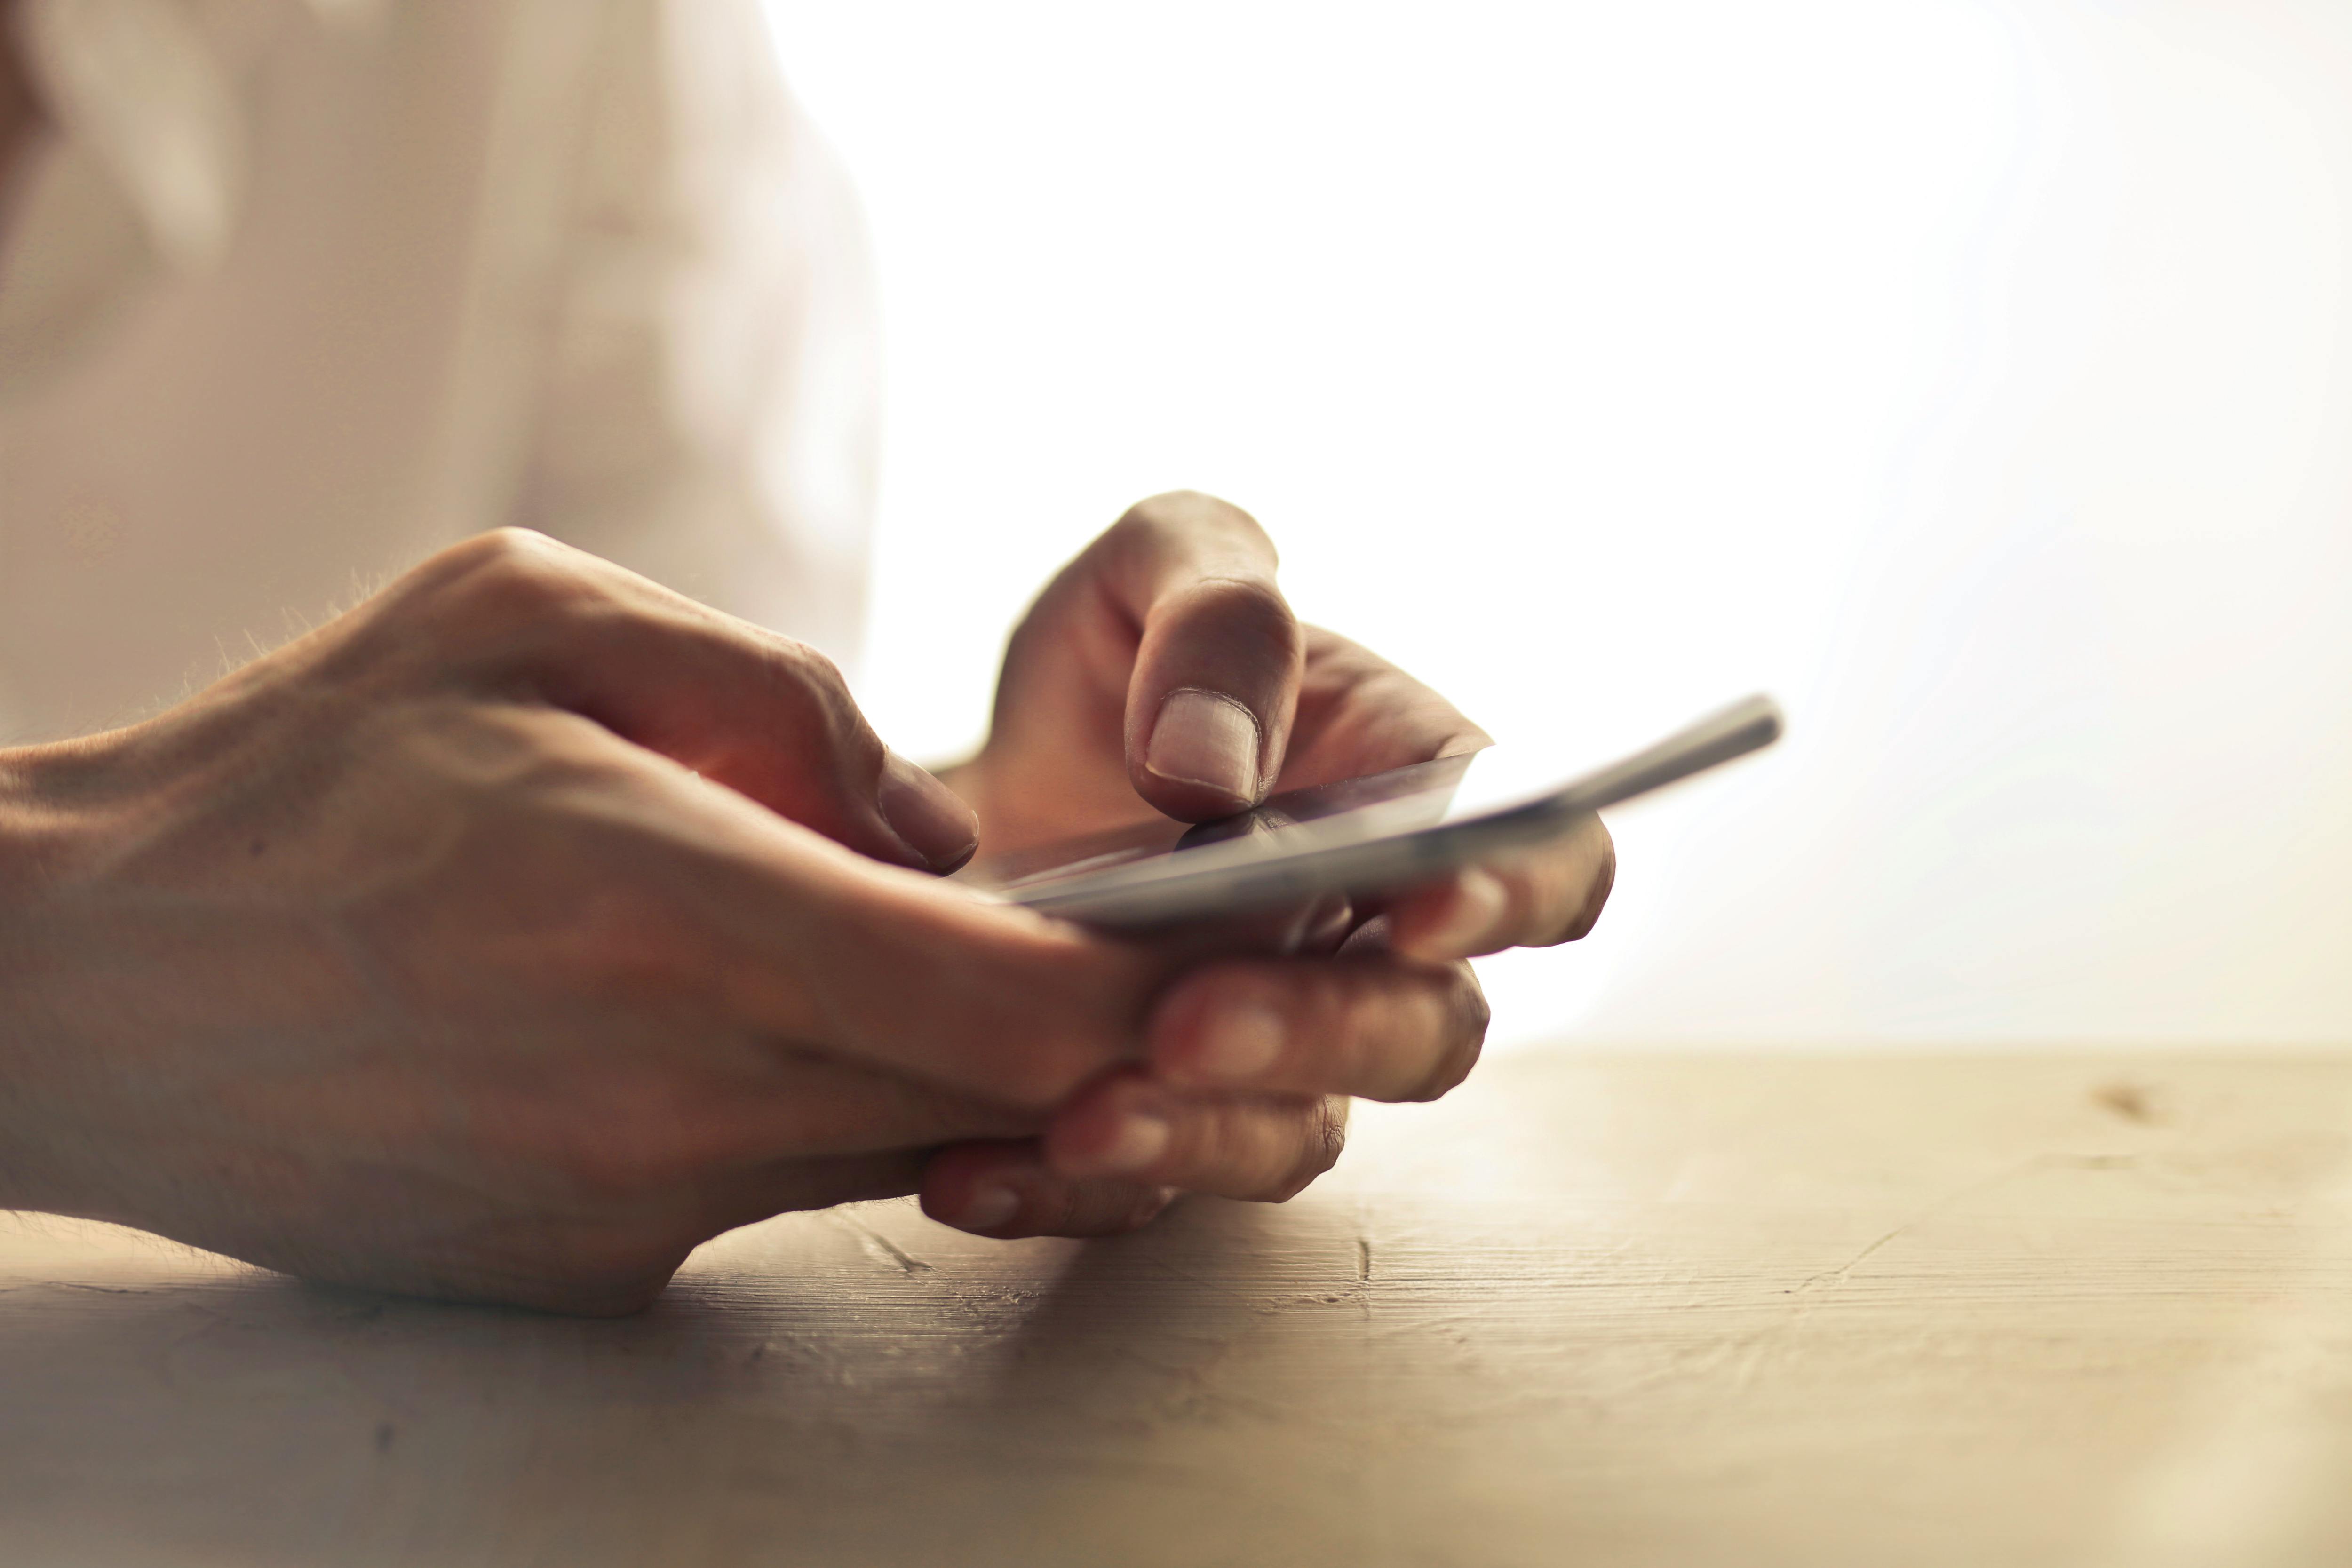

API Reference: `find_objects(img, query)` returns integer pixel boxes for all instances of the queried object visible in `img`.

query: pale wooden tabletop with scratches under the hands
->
[0,1056,2352,1568]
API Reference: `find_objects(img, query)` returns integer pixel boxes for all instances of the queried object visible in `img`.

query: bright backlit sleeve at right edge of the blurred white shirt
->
[515,0,877,663]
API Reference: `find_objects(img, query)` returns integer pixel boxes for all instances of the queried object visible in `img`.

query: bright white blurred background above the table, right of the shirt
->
[769,0,2352,1046]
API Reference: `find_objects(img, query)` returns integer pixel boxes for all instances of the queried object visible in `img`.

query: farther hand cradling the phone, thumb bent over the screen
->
[924,491,1616,1236]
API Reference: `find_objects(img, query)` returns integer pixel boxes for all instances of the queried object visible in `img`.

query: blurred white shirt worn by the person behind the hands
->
[0,0,875,743]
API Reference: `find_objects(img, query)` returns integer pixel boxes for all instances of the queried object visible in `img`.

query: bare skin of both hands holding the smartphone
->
[0,496,1606,1314]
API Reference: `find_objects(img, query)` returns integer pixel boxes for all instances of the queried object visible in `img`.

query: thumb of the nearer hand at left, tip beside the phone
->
[374,529,978,872]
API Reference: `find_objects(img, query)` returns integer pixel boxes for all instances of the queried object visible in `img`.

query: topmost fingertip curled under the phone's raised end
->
[1383,816,1616,962]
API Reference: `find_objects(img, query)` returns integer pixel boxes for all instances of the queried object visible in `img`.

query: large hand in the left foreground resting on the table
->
[0,533,1270,1312]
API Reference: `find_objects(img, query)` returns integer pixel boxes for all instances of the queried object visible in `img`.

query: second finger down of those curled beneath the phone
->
[1145,945,1486,1100]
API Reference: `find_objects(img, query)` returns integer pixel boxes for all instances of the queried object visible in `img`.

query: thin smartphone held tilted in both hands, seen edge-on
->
[960,696,1780,931]
